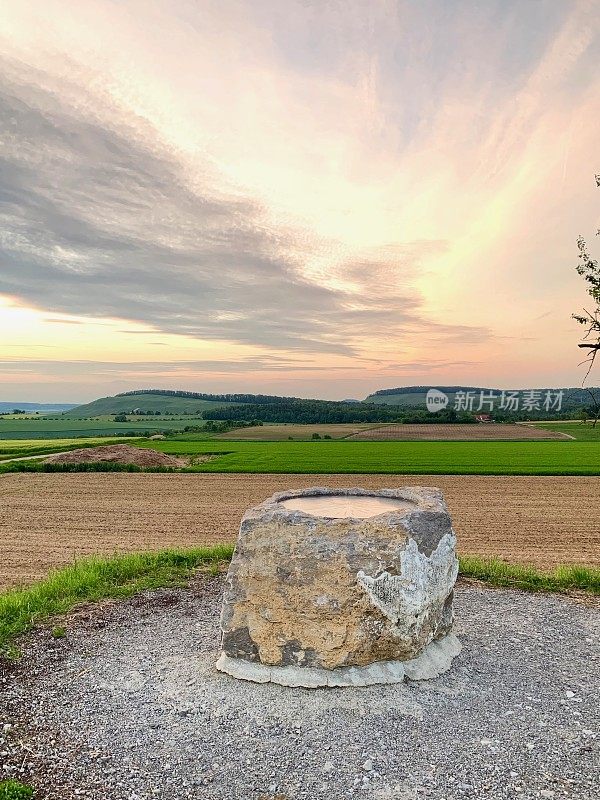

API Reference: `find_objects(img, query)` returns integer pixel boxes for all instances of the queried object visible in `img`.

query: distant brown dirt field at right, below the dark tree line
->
[348,423,573,442]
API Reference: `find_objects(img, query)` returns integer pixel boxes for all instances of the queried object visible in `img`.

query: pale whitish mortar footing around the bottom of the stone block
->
[217,633,461,689]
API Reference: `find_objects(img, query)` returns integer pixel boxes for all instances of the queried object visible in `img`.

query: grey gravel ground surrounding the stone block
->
[0,578,600,800]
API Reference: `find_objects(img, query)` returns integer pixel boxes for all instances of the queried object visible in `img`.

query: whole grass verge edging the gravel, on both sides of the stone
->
[0,545,600,657]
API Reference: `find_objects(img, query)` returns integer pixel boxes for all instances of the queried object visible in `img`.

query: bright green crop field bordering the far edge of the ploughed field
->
[136,438,600,475]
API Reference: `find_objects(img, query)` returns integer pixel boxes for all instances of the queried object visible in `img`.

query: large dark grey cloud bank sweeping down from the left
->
[0,56,482,355]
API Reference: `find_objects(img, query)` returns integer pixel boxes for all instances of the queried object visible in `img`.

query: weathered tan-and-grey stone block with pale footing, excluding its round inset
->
[218,487,459,686]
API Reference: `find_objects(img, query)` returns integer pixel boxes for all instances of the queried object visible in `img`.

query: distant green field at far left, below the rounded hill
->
[0,414,205,441]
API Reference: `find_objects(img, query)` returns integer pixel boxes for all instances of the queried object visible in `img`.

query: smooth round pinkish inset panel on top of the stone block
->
[279,494,416,519]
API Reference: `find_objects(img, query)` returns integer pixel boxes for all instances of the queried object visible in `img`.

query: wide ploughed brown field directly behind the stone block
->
[0,473,600,588]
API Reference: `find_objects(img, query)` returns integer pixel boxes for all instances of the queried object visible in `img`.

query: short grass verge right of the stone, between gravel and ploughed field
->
[460,556,600,595]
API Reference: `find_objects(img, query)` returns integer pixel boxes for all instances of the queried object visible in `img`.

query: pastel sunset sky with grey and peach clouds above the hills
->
[0,0,600,402]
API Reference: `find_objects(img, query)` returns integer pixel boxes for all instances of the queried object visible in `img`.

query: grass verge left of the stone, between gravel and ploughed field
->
[0,546,233,657]
